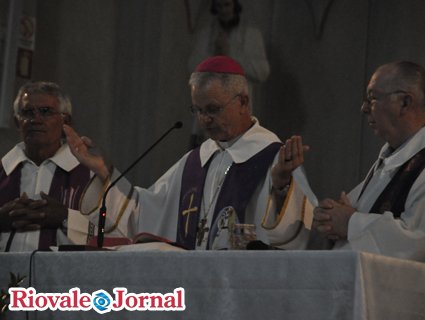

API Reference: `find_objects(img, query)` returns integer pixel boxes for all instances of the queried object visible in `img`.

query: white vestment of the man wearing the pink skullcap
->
[75,122,312,249]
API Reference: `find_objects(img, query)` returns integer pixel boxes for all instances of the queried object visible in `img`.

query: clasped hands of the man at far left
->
[0,192,68,232]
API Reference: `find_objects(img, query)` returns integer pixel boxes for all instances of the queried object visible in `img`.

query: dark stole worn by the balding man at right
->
[363,148,425,219]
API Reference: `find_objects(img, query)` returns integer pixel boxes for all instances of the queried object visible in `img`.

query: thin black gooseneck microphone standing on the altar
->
[97,121,183,248]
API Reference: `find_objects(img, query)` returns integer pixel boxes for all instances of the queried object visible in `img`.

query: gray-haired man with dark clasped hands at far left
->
[0,82,91,251]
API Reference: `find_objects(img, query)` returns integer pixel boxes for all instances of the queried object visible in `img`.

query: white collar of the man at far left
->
[1,142,79,175]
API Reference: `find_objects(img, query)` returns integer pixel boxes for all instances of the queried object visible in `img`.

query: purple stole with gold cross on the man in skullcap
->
[176,142,282,249]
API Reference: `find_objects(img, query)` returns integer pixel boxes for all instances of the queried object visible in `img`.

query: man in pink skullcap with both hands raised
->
[65,56,312,249]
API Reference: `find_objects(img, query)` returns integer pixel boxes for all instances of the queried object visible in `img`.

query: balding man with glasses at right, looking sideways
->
[312,61,425,262]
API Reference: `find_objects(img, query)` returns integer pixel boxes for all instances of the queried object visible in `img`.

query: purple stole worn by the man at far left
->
[0,163,90,250]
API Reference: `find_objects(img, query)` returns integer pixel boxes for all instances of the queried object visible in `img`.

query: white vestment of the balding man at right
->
[308,128,425,261]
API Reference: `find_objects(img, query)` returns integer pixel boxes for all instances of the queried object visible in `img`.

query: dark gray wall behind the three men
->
[0,0,425,198]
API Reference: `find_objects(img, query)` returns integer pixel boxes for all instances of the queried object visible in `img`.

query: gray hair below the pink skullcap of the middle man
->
[189,72,251,109]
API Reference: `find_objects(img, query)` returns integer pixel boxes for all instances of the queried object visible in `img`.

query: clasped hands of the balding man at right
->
[312,192,356,240]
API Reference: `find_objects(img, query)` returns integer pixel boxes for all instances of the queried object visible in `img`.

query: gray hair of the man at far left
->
[13,81,72,116]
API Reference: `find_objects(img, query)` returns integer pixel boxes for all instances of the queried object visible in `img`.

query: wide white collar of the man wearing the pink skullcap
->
[200,117,280,166]
